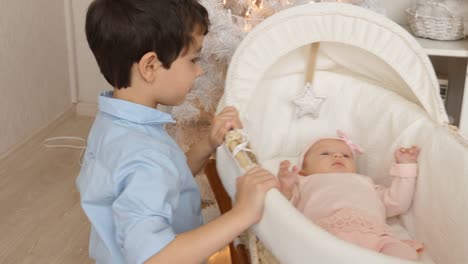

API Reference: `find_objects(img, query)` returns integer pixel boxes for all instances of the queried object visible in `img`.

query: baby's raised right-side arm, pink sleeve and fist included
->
[376,146,419,217]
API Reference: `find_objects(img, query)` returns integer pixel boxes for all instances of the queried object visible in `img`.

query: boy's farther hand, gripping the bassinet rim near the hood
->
[209,106,242,150]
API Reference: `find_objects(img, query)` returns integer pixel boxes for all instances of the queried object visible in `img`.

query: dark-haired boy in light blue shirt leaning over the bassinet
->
[77,0,278,264]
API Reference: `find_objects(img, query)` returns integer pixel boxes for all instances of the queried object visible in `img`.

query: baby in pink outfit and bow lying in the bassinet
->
[278,131,422,260]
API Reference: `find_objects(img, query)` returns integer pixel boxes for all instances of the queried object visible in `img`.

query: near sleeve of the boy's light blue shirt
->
[112,153,180,263]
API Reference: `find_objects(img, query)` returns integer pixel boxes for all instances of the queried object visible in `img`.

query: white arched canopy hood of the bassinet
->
[225,3,448,123]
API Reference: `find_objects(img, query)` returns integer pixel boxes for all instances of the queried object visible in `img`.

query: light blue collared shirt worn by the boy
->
[76,92,202,264]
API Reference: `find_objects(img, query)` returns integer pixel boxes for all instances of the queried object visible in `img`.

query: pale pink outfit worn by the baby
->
[291,164,422,260]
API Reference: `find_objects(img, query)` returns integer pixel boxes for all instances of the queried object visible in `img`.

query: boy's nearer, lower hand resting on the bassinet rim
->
[233,167,279,224]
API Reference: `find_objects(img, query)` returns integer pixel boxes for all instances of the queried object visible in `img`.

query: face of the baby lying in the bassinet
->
[301,139,356,175]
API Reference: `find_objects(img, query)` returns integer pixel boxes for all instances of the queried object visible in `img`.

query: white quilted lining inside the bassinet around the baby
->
[218,72,468,263]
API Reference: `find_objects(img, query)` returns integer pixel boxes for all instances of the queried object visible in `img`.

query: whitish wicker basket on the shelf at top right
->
[406,2,465,40]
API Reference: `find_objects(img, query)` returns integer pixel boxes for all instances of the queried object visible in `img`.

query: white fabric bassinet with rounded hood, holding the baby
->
[216,3,468,264]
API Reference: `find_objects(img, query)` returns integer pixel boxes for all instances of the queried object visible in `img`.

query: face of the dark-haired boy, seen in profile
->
[155,30,204,106]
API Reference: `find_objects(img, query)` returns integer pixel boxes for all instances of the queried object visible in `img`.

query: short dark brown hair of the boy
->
[86,0,209,88]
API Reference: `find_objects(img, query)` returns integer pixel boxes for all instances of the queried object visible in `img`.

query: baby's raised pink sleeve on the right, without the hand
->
[375,163,418,217]
